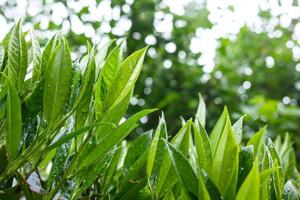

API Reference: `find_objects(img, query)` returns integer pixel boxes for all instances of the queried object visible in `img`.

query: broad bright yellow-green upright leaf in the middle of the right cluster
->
[212,117,239,196]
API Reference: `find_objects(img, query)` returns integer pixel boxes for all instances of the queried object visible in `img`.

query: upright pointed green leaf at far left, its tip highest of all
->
[6,21,28,91]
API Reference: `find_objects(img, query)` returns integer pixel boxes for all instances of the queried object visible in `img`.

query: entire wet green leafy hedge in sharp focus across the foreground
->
[0,22,300,199]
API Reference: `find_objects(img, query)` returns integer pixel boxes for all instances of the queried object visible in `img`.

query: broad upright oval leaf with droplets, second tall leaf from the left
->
[43,36,72,124]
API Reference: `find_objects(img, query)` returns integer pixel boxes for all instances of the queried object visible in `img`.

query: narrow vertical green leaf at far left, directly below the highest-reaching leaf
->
[6,77,22,160]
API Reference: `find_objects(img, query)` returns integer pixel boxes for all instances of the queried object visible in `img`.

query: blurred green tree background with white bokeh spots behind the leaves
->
[0,0,300,160]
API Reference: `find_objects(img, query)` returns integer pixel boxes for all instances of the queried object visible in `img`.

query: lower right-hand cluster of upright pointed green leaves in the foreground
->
[147,96,300,200]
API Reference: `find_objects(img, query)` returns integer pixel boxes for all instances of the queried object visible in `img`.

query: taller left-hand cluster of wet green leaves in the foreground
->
[0,21,154,199]
